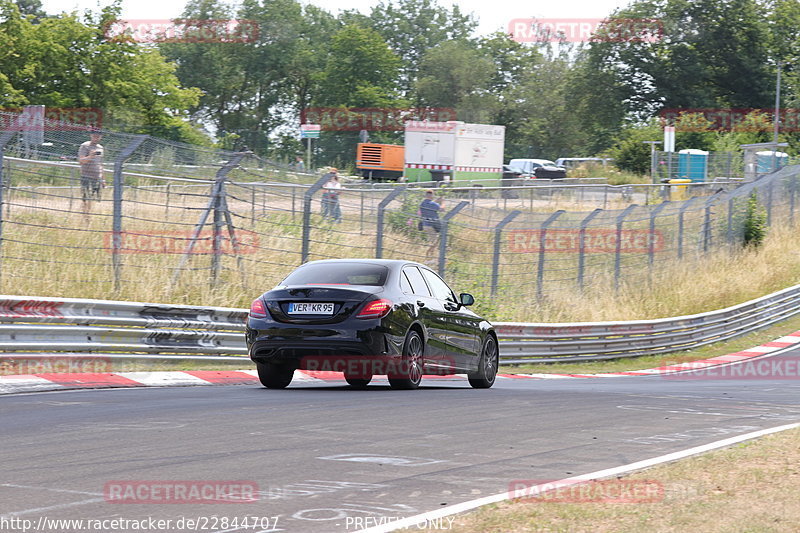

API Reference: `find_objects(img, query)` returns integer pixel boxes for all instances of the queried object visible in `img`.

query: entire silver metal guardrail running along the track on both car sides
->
[0,285,800,364]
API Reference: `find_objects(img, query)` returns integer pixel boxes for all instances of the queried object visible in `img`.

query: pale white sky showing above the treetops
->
[42,0,631,35]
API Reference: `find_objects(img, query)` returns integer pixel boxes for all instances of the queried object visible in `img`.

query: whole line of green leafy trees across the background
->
[0,0,800,172]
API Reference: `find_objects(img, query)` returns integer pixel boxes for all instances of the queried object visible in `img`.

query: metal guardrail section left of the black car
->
[0,296,247,361]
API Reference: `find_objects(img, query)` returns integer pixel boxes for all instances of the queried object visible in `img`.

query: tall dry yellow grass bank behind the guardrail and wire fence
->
[0,185,800,322]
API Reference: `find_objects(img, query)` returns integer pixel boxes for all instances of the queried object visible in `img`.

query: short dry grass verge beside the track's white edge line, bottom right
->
[429,429,800,533]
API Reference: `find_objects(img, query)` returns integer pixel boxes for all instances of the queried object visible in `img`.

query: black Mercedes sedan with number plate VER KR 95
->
[246,259,499,389]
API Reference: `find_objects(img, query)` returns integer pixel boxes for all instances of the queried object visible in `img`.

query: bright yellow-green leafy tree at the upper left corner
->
[0,0,199,140]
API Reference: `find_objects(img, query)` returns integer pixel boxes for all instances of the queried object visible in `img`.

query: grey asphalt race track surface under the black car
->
[0,349,800,532]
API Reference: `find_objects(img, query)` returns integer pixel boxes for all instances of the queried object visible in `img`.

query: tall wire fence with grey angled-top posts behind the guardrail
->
[0,112,800,312]
